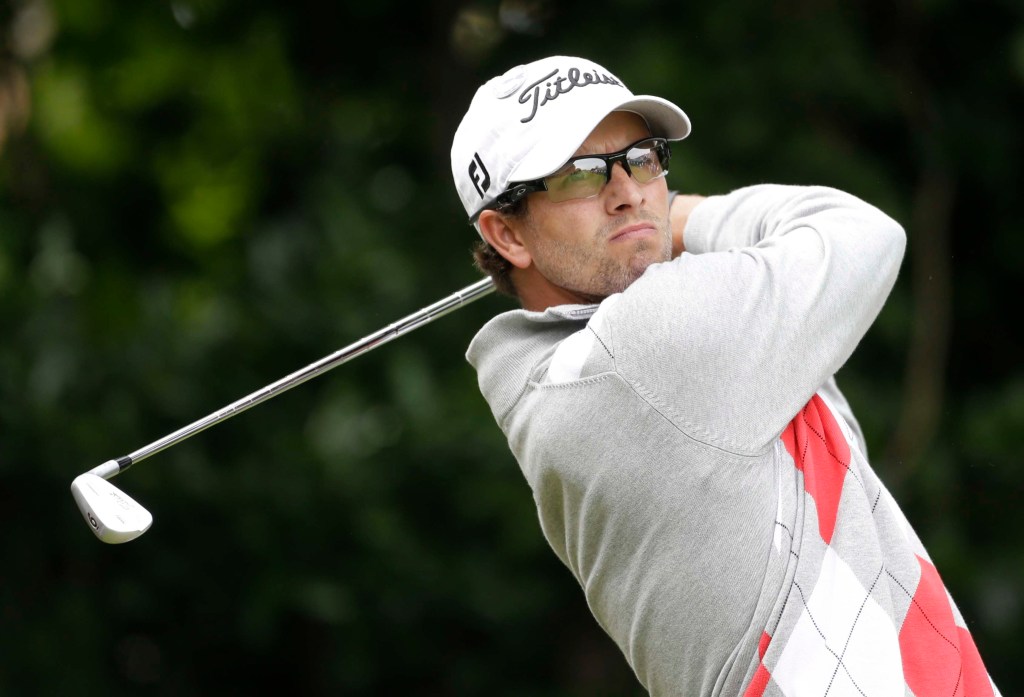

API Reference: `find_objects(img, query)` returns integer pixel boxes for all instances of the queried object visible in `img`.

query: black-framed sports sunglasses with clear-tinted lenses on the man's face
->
[469,138,672,224]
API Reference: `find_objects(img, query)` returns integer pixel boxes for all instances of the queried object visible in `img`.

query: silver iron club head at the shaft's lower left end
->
[71,473,153,544]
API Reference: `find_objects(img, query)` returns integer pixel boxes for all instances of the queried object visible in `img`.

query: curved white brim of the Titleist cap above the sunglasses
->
[509,95,690,183]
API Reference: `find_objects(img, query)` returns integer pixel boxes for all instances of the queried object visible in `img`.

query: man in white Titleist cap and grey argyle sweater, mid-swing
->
[452,56,998,696]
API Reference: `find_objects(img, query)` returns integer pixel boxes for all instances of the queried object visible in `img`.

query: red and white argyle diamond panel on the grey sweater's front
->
[744,395,999,697]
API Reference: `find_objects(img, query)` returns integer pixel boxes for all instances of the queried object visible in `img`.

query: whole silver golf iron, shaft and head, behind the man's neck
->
[71,278,495,544]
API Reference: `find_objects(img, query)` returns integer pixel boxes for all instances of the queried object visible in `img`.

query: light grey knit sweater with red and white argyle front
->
[467,185,998,696]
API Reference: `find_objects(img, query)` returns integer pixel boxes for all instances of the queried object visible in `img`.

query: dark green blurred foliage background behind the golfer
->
[0,0,1024,696]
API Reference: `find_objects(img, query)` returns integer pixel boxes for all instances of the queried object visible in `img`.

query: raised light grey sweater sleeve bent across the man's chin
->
[596,185,905,454]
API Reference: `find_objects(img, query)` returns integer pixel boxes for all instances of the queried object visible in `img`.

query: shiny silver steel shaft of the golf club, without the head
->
[92,277,495,479]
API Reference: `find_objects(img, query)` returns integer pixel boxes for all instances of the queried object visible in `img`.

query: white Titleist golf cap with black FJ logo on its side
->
[452,55,690,225]
